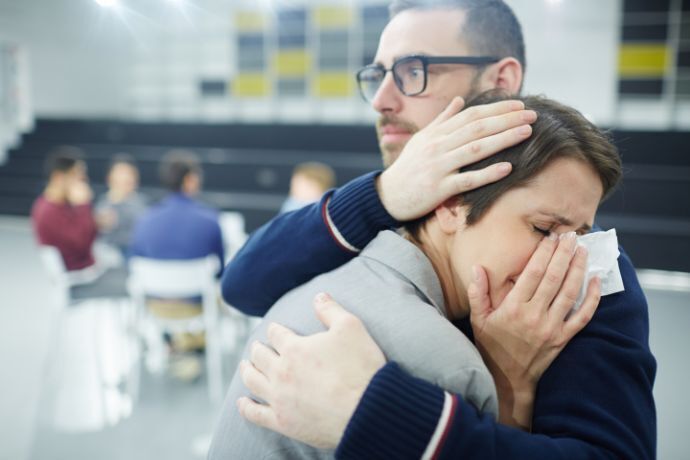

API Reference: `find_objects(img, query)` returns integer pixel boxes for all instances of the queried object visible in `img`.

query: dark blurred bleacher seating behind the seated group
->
[0,119,690,272]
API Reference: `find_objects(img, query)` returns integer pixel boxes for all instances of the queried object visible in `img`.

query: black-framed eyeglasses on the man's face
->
[357,55,500,102]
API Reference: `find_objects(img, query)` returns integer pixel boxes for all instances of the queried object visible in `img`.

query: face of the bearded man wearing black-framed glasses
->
[372,9,491,167]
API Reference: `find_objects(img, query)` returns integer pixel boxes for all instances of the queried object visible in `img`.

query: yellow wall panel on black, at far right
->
[618,43,670,78]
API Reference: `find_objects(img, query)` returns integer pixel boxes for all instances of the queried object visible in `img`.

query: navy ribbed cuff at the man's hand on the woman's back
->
[336,363,446,459]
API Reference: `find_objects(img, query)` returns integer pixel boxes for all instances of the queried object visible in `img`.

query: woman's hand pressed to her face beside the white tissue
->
[468,233,601,429]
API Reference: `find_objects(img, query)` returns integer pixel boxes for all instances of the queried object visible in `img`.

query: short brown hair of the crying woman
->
[405,90,623,237]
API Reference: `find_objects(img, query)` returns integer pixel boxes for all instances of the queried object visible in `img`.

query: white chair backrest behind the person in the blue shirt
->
[128,255,219,298]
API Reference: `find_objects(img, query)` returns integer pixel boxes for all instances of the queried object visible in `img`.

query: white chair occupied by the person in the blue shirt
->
[128,255,223,403]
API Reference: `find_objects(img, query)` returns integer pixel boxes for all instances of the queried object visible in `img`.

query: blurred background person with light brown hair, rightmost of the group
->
[280,162,335,213]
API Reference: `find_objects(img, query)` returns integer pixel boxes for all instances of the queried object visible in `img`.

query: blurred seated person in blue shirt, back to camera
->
[130,150,225,380]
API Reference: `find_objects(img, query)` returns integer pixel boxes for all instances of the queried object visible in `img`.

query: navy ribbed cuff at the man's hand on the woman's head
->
[324,171,401,252]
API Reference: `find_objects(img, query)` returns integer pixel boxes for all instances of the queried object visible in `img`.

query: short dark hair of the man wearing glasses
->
[388,0,527,72]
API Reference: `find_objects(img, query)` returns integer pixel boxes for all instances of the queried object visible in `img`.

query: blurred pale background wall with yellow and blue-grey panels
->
[0,0,690,129]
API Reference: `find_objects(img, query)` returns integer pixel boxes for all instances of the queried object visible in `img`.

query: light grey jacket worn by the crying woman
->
[209,231,498,459]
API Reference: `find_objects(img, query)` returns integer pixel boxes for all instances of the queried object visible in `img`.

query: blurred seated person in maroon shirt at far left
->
[31,147,97,271]
